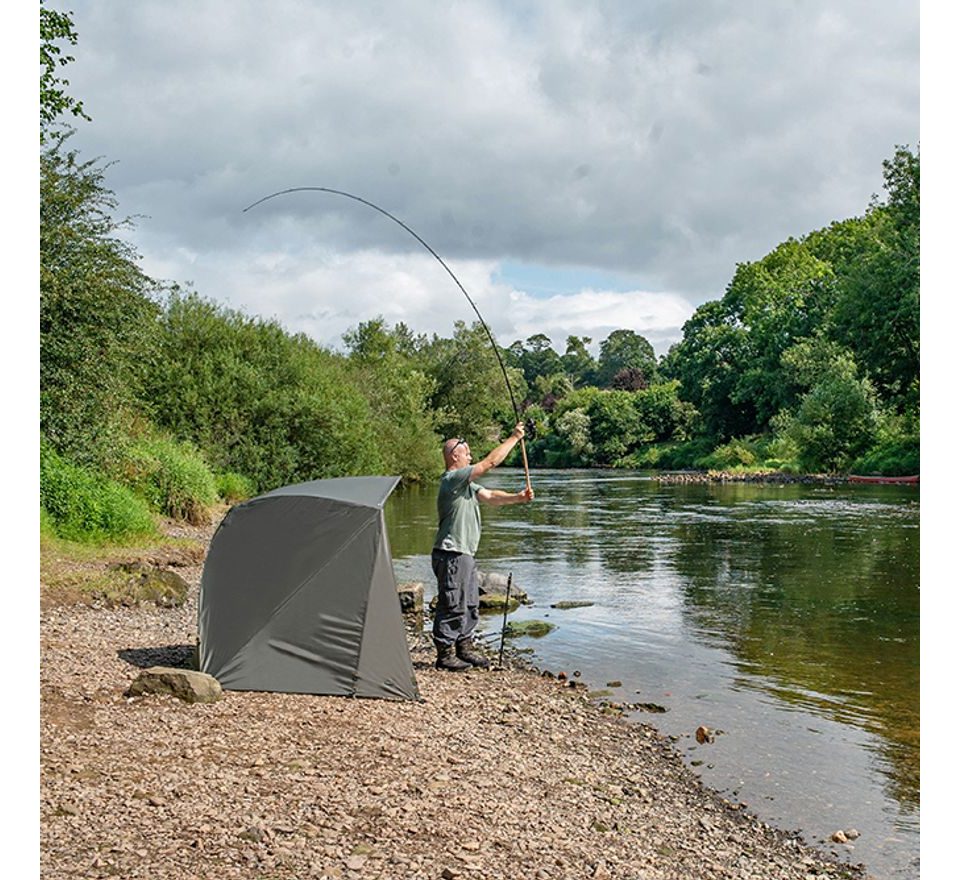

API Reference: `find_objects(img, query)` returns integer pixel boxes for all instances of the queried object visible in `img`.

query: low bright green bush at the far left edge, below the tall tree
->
[40,443,156,543]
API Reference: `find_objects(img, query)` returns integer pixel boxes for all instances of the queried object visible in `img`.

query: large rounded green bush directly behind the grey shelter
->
[148,291,384,490]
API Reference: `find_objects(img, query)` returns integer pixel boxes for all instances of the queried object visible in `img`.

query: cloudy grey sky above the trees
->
[48,0,920,353]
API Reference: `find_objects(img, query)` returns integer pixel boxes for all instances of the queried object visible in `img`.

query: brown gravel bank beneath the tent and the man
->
[41,524,860,880]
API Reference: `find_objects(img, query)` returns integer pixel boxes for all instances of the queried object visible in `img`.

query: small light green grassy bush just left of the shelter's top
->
[114,437,219,524]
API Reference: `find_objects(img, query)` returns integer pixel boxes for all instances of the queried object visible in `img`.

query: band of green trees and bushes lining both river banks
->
[40,135,920,536]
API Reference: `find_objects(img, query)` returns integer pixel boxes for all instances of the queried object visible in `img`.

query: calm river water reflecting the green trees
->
[386,469,920,878]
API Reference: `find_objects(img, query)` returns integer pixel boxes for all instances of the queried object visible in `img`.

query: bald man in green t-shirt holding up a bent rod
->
[431,422,533,672]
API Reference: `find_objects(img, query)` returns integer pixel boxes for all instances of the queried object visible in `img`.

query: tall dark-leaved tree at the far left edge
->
[40,135,159,465]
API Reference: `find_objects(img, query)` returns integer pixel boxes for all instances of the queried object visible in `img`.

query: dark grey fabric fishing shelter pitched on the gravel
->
[198,477,420,700]
